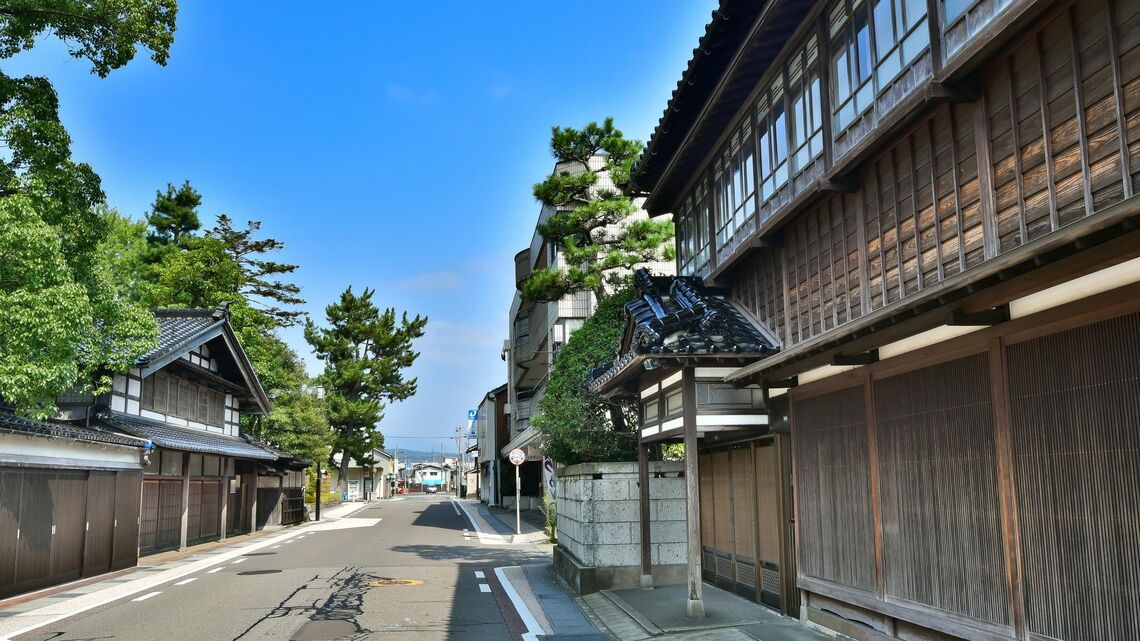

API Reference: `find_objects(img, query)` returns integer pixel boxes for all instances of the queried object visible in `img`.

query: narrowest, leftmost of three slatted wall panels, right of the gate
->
[792,386,876,590]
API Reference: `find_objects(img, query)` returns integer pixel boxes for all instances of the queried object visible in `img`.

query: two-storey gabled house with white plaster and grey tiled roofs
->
[96,309,279,554]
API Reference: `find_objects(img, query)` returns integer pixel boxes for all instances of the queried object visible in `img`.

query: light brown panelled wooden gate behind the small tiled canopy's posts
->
[699,440,793,611]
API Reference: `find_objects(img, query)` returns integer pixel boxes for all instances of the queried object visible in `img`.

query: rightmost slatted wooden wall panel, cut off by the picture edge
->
[1007,314,1140,641]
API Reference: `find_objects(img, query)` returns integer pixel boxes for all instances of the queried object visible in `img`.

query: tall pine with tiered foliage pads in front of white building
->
[522,117,674,301]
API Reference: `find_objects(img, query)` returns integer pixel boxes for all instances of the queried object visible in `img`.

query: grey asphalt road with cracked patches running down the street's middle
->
[17,496,545,641]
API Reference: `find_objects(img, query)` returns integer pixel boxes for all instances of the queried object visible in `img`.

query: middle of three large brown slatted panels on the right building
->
[874,354,1011,625]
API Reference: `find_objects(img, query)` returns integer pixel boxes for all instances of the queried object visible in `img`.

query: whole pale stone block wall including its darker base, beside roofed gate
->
[555,461,686,594]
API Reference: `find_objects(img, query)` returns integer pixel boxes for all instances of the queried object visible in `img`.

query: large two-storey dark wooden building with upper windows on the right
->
[597,0,1140,641]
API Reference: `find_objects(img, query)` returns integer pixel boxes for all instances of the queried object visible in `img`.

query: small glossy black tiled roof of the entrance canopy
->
[589,269,780,391]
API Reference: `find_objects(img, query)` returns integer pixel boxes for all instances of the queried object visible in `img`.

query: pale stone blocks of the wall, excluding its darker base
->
[557,461,687,567]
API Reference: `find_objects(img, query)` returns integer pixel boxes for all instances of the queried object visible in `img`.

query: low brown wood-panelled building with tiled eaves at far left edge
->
[0,408,150,598]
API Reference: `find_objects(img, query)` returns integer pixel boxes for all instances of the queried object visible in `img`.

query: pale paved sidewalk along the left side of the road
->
[0,503,374,641]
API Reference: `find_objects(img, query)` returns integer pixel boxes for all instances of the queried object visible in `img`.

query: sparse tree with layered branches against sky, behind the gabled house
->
[209,214,304,327]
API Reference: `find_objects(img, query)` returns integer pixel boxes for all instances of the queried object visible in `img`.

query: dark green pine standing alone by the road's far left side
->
[304,286,428,486]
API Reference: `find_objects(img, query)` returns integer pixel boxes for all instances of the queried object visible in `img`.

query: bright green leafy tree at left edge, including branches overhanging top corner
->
[0,0,176,416]
